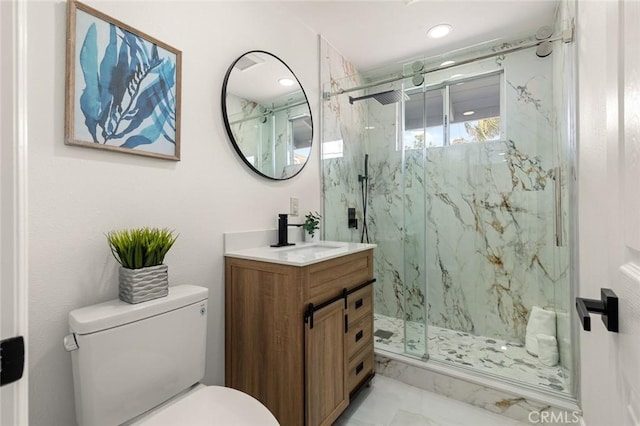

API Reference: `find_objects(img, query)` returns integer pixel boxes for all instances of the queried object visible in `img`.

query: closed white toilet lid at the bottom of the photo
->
[137,386,279,426]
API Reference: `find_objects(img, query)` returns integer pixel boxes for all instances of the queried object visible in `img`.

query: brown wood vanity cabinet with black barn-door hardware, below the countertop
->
[225,249,375,426]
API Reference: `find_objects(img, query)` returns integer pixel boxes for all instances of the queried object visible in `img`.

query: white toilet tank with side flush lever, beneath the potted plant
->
[69,285,208,426]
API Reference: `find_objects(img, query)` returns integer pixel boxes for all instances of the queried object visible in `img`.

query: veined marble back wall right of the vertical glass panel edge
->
[425,50,568,342]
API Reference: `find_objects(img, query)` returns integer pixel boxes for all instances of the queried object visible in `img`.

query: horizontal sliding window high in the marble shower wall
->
[404,73,503,150]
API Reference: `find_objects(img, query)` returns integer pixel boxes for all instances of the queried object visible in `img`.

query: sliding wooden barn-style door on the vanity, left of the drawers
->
[305,299,349,426]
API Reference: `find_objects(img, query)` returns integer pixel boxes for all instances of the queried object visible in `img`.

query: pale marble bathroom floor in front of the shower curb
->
[334,374,527,426]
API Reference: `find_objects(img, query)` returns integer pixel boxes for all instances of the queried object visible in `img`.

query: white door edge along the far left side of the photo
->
[0,0,29,426]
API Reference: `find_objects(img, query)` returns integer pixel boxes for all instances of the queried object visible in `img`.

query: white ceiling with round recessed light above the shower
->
[278,0,558,71]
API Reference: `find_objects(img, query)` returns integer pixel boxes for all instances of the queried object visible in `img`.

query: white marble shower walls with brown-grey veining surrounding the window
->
[323,40,569,342]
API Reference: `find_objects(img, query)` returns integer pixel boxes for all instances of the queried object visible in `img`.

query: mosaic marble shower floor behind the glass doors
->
[373,314,567,392]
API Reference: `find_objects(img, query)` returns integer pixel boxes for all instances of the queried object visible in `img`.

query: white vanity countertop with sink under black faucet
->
[224,241,376,266]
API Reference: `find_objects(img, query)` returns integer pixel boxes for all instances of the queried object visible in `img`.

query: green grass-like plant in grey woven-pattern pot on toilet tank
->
[107,228,178,303]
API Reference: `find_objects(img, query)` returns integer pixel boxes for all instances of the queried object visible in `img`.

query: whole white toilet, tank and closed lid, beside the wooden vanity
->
[65,285,278,426]
